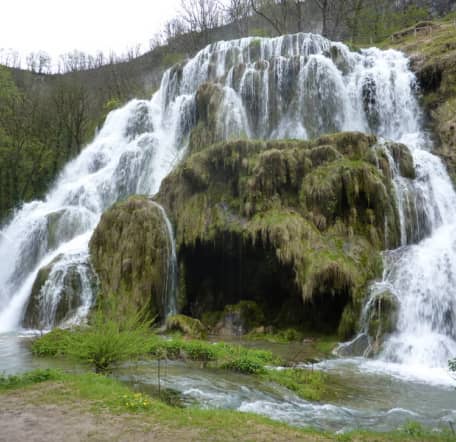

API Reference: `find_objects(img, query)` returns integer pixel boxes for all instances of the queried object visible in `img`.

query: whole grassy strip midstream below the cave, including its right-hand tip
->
[32,327,329,401]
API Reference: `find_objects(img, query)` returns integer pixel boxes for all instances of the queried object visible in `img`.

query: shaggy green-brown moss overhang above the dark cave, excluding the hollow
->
[158,133,402,336]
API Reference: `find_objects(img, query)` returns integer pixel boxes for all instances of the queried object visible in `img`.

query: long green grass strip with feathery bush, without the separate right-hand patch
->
[32,322,282,374]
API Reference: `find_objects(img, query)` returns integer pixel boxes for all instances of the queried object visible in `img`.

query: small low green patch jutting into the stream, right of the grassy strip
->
[264,368,327,401]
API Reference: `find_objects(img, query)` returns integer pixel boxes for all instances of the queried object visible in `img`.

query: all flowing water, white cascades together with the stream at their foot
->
[0,34,456,430]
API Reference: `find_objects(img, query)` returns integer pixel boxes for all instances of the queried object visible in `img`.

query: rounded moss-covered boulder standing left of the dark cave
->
[90,196,169,317]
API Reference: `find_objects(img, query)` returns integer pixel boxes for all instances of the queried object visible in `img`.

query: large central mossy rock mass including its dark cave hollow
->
[157,133,413,337]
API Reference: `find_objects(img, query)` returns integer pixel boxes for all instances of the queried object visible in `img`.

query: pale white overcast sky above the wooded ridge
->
[0,0,179,58]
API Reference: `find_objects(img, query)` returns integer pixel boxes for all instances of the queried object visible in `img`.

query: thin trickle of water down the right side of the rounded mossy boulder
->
[152,201,177,317]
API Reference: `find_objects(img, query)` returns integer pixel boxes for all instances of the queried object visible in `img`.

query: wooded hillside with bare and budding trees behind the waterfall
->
[0,0,456,221]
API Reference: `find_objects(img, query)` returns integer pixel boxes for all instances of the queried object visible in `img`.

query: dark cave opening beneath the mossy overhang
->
[179,233,350,333]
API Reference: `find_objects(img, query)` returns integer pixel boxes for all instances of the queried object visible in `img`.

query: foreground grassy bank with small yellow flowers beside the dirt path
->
[0,370,454,442]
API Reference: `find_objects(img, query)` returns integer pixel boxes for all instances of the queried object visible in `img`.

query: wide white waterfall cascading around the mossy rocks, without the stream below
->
[0,33,456,376]
